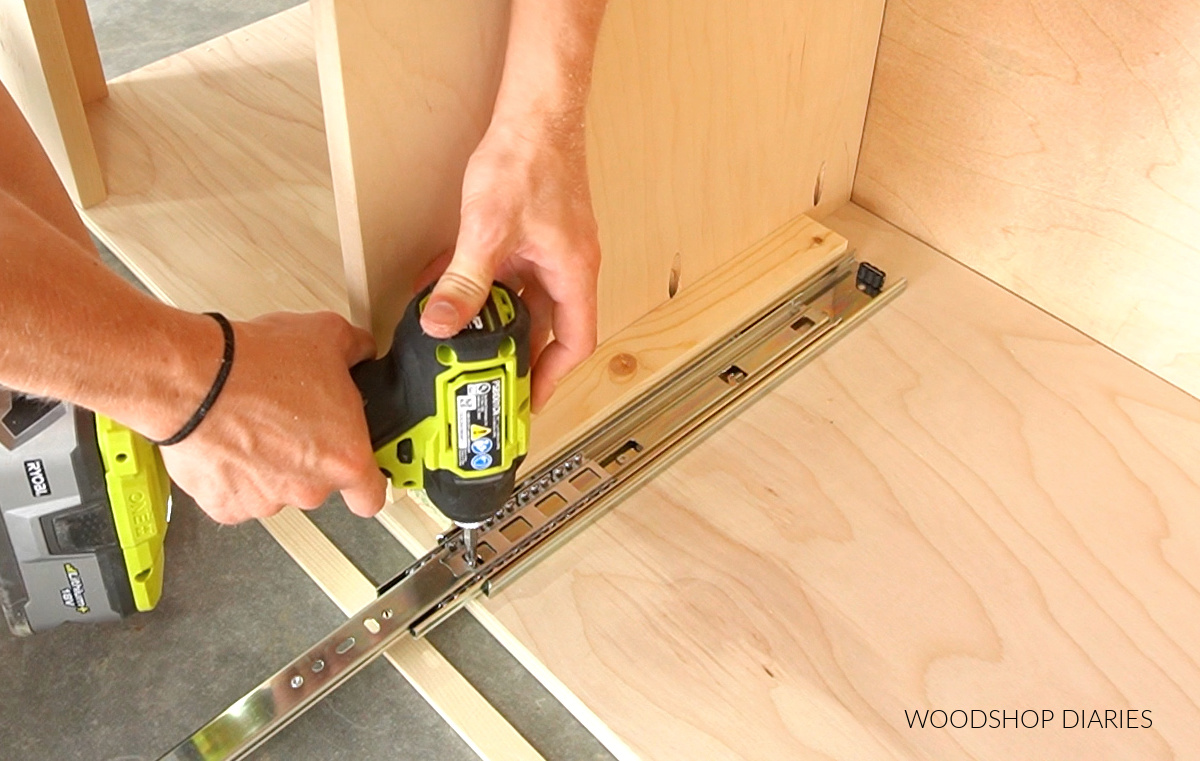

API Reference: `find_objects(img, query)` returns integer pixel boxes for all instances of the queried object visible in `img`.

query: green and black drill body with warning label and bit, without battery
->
[350,283,529,564]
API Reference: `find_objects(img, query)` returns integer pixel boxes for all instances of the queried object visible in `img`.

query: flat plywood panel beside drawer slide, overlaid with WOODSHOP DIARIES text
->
[472,206,1200,760]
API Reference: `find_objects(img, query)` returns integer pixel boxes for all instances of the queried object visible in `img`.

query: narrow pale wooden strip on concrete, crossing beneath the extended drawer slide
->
[262,508,542,761]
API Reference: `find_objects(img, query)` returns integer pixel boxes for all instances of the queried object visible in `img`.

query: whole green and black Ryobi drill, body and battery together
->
[0,284,529,635]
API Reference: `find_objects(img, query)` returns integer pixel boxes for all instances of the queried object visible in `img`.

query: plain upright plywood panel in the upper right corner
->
[854,0,1200,395]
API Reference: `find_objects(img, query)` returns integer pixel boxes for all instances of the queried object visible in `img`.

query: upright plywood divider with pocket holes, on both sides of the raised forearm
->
[314,0,883,340]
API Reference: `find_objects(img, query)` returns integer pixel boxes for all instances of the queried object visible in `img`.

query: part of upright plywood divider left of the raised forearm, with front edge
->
[312,0,508,347]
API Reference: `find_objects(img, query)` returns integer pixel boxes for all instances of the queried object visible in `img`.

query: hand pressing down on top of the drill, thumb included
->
[418,114,600,411]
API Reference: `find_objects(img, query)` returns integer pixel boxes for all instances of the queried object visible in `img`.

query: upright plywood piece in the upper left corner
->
[0,0,106,206]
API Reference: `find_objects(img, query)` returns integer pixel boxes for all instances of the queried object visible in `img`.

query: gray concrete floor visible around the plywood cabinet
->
[0,0,611,761]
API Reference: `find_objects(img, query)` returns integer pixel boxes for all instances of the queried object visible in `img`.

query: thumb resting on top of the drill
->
[421,212,504,338]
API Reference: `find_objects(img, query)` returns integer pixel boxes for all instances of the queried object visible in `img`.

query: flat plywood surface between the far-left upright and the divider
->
[84,5,347,318]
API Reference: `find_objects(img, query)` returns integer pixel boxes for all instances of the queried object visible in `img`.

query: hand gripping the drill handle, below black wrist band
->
[162,312,386,523]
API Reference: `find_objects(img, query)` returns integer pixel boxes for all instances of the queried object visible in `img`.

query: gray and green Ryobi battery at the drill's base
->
[0,388,170,635]
